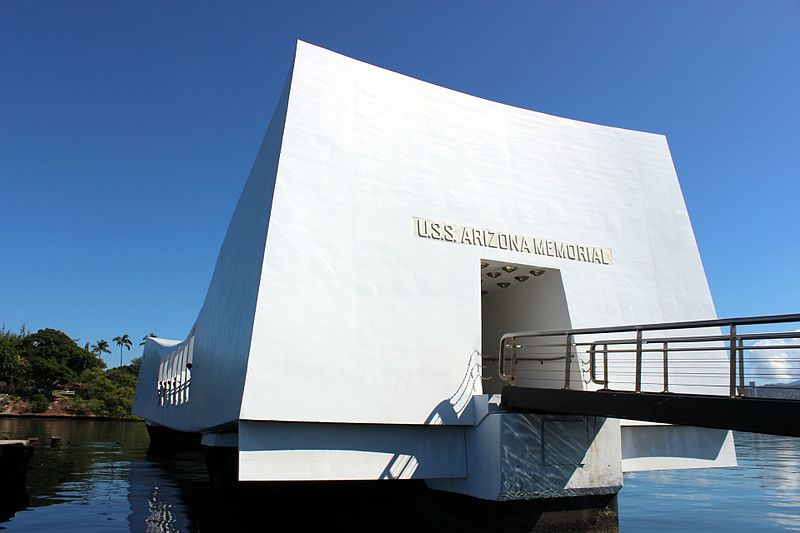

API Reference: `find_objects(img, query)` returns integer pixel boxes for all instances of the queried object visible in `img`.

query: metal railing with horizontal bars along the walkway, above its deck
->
[497,314,800,399]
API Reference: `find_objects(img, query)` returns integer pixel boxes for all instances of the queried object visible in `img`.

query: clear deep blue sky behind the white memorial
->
[0,0,800,364]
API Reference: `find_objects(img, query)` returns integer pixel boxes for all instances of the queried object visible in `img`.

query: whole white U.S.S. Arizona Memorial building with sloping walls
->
[134,42,736,500]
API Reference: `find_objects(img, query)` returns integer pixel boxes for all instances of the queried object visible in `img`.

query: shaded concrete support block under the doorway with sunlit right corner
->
[427,396,622,501]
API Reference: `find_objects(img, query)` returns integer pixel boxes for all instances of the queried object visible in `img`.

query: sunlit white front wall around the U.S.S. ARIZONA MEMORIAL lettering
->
[241,43,715,424]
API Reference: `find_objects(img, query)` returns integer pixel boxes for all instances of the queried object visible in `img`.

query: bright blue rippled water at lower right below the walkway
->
[619,433,800,533]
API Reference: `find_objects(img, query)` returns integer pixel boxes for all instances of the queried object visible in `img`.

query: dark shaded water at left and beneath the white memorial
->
[0,418,616,533]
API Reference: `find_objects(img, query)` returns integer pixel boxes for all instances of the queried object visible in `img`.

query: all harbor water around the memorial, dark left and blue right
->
[0,419,800,533]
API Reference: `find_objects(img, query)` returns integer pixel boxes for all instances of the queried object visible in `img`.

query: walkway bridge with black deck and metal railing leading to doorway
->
[498,314,800,437]
